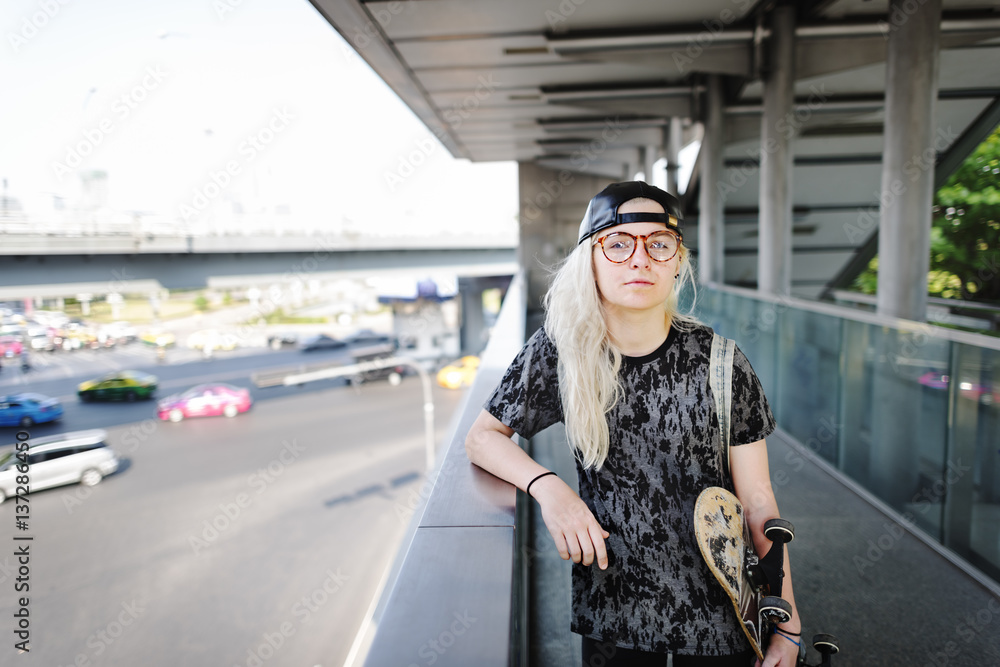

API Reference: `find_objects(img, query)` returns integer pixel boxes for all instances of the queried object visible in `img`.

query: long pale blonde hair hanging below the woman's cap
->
[543,219,700,470]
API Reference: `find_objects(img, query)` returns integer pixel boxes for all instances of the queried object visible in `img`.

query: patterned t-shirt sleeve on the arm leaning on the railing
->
[483,329,563,438]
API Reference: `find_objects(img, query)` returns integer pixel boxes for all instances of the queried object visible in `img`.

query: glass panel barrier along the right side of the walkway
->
[696,287,1000,580]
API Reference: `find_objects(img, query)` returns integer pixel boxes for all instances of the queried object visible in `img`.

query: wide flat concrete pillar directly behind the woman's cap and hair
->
[517,162,611,316]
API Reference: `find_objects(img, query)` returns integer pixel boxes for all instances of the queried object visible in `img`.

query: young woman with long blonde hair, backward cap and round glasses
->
[466,182,801,667]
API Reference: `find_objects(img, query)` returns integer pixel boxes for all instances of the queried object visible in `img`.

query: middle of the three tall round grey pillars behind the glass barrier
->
[757,4,795,295]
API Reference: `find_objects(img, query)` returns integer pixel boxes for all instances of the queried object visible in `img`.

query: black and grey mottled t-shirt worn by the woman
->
[485,326,775,655]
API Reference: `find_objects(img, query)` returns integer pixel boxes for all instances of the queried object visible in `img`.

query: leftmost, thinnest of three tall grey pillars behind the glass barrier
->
[698,74,725,283]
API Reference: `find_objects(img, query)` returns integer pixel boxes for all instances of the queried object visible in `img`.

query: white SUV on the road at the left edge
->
[0,429,118,503]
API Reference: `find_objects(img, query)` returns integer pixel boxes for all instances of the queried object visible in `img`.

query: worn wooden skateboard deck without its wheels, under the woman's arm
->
[694,487,771,660]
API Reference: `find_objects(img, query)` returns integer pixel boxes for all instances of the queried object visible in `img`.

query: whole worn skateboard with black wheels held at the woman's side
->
[694,486,840,667]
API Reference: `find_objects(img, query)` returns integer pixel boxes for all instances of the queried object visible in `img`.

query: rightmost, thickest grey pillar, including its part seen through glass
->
[869,0,950,511]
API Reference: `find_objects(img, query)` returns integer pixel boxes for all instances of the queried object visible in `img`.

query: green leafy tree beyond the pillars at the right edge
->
[854,126,1000,303]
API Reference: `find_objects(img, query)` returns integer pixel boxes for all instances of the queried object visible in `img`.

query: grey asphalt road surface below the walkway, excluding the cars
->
[0,350,462,667]
